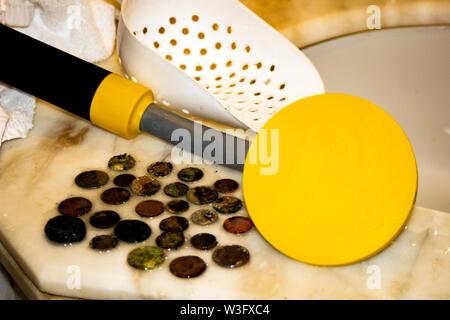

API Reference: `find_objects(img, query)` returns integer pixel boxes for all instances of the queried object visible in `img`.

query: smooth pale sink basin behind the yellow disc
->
[303,26,450,212]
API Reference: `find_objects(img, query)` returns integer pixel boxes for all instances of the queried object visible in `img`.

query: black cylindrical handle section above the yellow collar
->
[0,24,110,120]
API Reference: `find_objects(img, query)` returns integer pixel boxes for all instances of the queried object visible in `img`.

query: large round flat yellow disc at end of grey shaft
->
[243,93,417,266]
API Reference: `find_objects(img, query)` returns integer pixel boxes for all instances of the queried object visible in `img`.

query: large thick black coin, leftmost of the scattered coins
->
[45,215,86,243]
